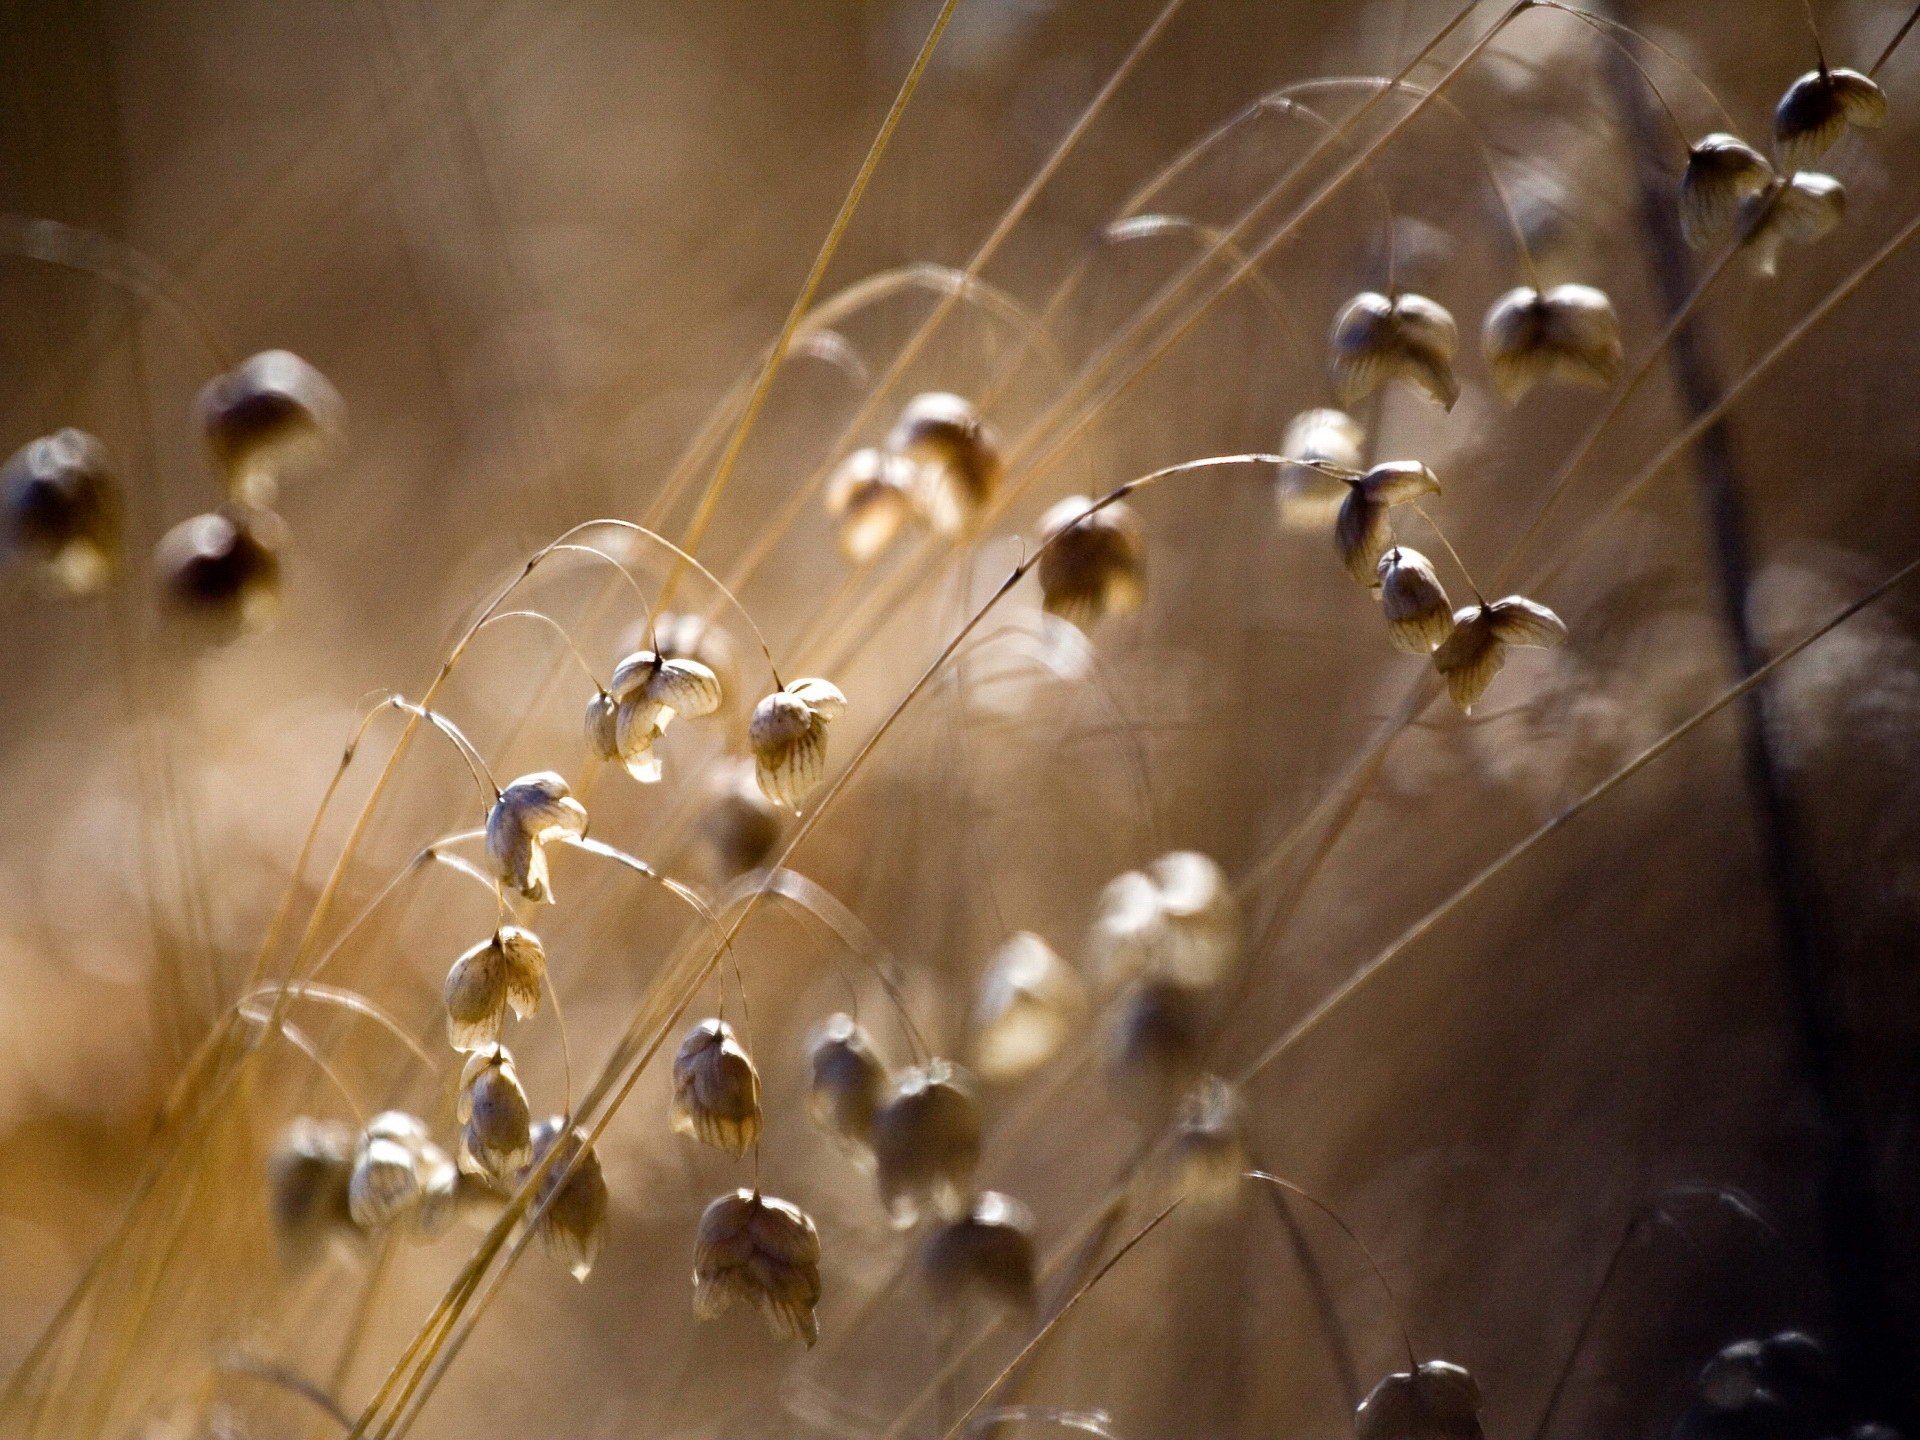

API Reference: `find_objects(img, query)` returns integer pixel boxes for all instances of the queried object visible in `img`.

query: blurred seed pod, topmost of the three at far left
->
[194,349,346,505]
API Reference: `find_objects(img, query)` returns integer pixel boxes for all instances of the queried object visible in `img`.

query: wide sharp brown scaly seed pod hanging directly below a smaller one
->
[693,1190,820,1346]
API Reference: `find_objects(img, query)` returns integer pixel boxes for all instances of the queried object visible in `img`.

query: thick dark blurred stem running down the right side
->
[1609,14,1912,1427]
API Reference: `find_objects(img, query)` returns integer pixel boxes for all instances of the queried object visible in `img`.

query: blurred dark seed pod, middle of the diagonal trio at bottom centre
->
[872,1060,979,1229]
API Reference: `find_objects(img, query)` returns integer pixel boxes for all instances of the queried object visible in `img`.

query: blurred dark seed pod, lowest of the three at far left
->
[154,505,286,641]
